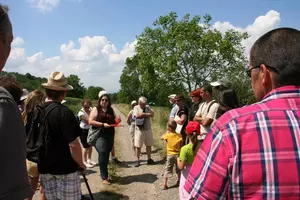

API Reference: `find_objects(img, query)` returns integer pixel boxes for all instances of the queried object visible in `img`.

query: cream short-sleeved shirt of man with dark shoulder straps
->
[196,100,219,134]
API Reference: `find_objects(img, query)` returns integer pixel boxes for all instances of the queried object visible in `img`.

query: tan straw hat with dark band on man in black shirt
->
[42,72,73,91]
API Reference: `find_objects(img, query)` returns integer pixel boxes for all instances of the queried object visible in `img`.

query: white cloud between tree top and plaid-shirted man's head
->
[213,10,280,56]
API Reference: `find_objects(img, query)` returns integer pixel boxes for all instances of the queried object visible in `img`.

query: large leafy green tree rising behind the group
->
[135,12,249,103]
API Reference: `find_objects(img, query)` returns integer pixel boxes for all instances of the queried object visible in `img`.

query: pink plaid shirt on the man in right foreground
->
[184,86,300,199]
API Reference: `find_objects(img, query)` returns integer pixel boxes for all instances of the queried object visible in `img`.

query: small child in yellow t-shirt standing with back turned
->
[161,121,183,190]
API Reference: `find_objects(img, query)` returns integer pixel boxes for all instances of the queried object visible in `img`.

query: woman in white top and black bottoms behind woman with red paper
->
[78,99,96,167]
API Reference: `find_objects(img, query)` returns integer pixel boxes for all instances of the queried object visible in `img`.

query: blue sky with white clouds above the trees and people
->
[1,0,300,92]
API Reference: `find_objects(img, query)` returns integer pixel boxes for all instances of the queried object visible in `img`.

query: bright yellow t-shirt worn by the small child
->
[163,131,182,155]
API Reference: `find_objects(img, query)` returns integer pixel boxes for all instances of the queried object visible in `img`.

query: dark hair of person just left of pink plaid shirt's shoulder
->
[218,89,239,109]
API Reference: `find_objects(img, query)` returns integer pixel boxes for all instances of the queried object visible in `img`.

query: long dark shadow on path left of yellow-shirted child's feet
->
[118,173,158,185]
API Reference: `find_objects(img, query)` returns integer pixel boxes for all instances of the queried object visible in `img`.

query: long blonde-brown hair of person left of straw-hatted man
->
[22,90,46,125]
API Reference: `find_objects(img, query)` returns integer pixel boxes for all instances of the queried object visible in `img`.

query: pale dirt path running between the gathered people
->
[34,107,179,200]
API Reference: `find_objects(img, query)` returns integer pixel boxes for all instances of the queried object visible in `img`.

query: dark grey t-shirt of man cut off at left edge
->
[0,87,33,200]
